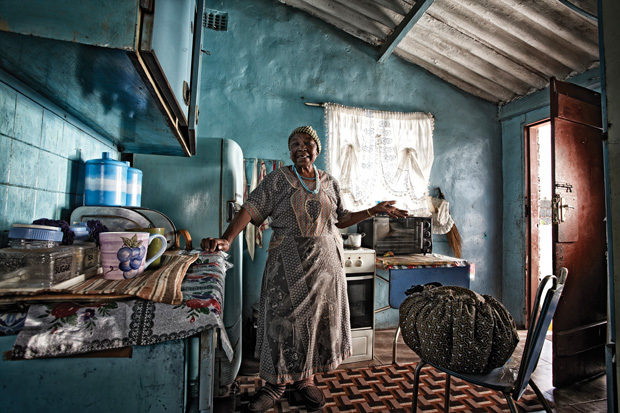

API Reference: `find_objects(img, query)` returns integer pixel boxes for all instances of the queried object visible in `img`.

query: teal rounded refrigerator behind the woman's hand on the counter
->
[132,137,244,397]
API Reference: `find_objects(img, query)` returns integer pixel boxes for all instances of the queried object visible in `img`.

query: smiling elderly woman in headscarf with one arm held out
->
[201,126,407,412]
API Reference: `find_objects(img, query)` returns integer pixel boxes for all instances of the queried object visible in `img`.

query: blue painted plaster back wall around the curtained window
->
[198,0,502,327]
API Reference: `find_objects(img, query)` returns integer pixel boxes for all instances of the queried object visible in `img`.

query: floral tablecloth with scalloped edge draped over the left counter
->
[6,250,233,360]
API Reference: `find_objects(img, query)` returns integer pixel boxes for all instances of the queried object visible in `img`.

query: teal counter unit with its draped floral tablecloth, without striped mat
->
[0,251,233,412]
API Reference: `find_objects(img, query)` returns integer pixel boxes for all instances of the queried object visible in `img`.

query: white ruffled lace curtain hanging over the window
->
[325,103,434,216]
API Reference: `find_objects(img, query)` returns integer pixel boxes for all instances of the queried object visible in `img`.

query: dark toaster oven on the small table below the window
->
[357,216,433,256]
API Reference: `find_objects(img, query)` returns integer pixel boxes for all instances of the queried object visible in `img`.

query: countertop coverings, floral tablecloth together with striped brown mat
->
[1,251,232,358]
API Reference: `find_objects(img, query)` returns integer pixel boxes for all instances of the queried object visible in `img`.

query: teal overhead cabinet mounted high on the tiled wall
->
[0,0,204,156]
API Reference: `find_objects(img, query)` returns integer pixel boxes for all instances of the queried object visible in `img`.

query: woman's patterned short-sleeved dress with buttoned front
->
[243,167,351,383]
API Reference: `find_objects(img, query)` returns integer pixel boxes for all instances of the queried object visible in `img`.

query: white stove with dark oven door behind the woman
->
[344,248,376,363]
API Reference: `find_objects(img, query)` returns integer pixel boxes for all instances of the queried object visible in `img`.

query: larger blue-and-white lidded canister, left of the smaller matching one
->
[84,152,127,206]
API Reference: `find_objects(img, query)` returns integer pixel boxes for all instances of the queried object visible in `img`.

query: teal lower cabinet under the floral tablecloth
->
[0,329,216,413]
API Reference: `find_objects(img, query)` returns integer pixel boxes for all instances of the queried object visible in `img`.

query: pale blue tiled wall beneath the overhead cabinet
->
[0,80,118,247]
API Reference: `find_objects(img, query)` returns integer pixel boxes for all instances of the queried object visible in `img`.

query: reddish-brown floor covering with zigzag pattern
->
[236,363,543,413]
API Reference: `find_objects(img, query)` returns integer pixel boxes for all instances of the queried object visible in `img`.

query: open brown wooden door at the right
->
[551,79,607,387]
